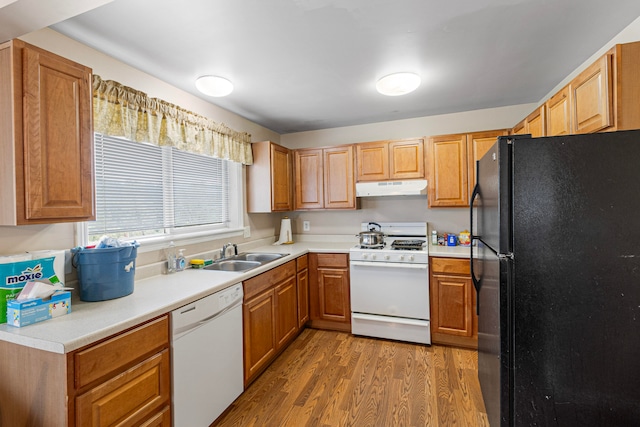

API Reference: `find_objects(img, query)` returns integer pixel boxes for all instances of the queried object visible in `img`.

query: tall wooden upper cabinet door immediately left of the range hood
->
[323,146,356,209]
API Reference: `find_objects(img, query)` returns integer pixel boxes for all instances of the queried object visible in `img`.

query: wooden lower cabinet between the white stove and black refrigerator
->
[430,257,478,348]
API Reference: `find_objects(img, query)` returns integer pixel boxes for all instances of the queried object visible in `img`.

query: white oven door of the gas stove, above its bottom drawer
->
[350,261,429,320]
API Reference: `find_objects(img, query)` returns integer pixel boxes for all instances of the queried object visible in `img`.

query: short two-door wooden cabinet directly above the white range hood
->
[356,138,424,182]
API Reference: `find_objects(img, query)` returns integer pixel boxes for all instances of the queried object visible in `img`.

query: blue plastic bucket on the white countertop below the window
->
[73,245,138,301]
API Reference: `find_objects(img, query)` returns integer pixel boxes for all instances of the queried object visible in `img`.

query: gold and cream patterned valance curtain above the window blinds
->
[93,74,253,165]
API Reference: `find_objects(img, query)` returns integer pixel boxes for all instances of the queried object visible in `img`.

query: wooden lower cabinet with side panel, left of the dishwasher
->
[0,315,171,427]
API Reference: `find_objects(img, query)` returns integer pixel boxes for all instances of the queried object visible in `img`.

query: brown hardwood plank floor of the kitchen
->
[214,328,489,427]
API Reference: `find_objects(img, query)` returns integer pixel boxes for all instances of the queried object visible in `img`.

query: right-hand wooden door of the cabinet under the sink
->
[274,276,298,350]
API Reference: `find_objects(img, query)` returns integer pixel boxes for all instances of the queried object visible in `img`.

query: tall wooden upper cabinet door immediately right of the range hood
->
[428,134,469,207]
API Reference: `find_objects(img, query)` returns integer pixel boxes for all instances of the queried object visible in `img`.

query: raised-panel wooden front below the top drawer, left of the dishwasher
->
[76,350,171,426]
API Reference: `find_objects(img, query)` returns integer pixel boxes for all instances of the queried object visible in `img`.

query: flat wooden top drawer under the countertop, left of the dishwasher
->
[73,316,169,388]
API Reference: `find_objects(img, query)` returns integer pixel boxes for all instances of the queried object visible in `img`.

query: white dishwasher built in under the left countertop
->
[171,283,244,427]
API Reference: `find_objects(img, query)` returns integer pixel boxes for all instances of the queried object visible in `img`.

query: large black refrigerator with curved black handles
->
[471,131,640,427]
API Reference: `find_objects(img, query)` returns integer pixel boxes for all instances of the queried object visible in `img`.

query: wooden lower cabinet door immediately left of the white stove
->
[318,268,351,323]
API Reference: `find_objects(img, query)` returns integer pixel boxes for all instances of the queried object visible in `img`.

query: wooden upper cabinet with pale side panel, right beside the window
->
[247,141,293,212]
